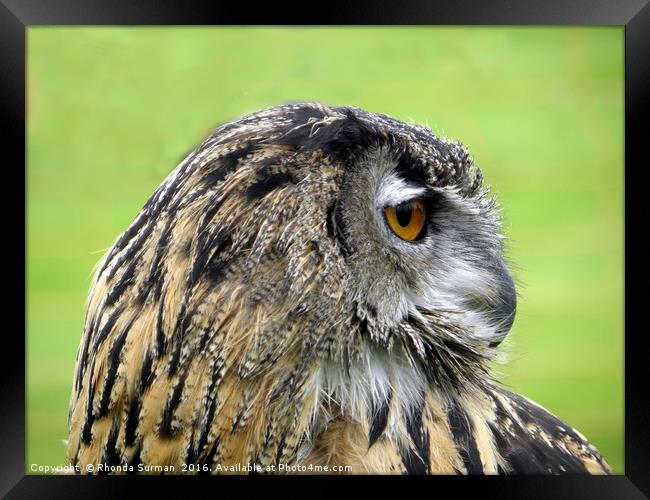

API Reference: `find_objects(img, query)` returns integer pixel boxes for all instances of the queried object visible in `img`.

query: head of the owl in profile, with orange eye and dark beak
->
[82,103,516,410]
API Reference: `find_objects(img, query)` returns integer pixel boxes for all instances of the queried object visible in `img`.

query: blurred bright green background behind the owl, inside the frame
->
[26,27,624,473]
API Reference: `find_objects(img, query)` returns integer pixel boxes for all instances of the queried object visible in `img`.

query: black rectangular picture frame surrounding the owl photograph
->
[0,0,650,498]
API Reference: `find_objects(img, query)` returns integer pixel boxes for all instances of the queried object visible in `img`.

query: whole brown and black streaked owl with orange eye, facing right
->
[67,103,611,474]
